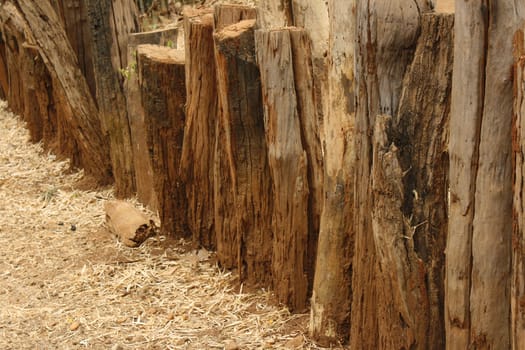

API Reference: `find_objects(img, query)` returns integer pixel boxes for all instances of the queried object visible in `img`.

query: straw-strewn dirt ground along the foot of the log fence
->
[0,102,340,350]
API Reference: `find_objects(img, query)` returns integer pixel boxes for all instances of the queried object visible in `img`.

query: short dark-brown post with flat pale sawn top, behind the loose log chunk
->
[137,45,189,237]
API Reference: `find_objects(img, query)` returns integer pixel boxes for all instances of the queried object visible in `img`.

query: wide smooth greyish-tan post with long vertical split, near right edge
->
[445,0,525,349]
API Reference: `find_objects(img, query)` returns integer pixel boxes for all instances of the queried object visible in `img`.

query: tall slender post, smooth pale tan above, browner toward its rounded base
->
[310,0,356,346]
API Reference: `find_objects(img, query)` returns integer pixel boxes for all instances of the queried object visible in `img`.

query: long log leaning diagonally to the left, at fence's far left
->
[4,0,112,184]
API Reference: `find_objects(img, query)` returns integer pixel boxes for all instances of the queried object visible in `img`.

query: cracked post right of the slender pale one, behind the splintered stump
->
[350,0,426,349]
